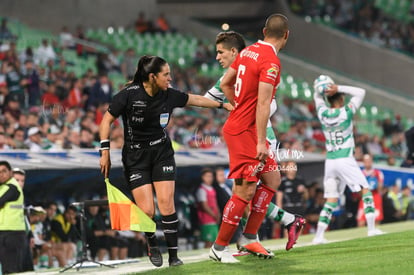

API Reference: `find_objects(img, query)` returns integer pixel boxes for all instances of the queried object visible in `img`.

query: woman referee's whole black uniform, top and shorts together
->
[108,84,188,190]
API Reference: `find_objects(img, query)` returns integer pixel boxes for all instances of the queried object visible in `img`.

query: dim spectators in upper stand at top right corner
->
[289,0,414,55]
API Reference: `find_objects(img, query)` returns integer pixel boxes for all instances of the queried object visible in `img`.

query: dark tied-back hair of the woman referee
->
[133,55,167,87]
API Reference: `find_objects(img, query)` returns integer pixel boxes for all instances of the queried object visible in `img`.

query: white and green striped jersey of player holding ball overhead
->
[314,85,365,159]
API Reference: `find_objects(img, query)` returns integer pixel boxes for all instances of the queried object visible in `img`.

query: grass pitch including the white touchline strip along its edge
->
[34,221,414,275]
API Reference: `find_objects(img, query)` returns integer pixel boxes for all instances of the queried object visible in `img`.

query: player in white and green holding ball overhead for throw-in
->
[313,75,382,244]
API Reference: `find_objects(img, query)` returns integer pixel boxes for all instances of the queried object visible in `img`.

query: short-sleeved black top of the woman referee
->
[108,84,188,144]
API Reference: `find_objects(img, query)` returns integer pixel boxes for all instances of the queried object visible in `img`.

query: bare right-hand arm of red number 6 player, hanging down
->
[256,82,274,161]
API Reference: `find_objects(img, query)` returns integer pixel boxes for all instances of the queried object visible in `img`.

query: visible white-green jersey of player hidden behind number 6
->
[204,76,277,150]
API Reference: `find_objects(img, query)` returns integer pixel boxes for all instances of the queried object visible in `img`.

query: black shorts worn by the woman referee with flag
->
[122,138,176,190]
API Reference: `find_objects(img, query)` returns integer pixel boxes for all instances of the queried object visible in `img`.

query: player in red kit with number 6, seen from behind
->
[209,14,304,263]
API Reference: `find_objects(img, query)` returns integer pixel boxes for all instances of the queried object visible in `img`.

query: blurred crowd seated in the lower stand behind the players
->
[0,15,414,170]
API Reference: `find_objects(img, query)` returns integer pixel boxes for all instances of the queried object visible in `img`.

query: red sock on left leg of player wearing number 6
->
[216,195,247,246]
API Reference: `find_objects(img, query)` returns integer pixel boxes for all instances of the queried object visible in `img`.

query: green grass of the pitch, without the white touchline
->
[137,224,414,275]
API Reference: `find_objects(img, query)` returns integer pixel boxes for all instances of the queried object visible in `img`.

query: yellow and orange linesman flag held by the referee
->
[105,178,156,232]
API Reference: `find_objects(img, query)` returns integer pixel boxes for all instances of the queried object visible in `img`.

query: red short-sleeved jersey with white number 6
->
[223,40,280,135]
